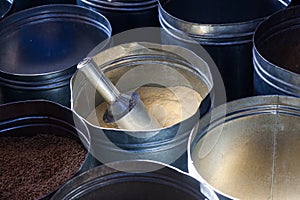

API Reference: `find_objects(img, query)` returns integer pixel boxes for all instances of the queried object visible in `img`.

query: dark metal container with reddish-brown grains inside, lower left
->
[0,100,97,199]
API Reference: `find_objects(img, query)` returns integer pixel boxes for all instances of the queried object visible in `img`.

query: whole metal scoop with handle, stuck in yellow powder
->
[77,58,161,130]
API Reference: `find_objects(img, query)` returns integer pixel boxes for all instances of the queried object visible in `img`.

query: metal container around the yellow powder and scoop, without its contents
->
[71,43,213,171]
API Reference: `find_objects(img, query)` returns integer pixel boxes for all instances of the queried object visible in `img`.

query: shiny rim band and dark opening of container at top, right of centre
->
[159,0,290,45]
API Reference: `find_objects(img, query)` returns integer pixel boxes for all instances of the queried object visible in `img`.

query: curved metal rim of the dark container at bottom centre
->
[51,159,218,200]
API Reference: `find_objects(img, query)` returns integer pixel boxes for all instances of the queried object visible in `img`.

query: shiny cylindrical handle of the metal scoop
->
[77,57,121,104]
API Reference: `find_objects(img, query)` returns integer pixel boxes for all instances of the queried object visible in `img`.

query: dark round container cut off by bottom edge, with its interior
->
[52,160,216,200]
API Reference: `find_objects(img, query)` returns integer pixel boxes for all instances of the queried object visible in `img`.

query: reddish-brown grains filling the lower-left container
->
[0,134,87,199]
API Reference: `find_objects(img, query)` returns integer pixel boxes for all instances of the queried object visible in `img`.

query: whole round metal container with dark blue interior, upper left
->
[0,5,111,106]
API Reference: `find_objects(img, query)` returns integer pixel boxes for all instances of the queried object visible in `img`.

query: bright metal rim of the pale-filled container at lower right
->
[187,95,300,199]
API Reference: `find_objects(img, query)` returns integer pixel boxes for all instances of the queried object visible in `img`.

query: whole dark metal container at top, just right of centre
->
[159,0,289,100]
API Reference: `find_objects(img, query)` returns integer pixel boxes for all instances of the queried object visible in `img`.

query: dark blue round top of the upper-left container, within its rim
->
[0,4,111,75]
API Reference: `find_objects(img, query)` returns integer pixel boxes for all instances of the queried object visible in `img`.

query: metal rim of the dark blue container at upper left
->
[0,4,112,77]
